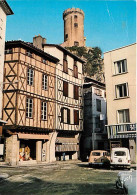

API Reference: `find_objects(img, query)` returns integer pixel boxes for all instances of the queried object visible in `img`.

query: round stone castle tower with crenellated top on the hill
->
[62,8,85,47]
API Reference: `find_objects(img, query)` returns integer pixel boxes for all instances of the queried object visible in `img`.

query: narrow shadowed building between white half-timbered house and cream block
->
[81,77,109,160]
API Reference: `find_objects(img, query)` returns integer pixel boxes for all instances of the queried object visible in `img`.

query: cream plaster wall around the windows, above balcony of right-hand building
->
[104,44,136,125]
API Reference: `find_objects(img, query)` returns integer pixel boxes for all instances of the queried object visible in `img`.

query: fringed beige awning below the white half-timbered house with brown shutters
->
[56,137,79,144]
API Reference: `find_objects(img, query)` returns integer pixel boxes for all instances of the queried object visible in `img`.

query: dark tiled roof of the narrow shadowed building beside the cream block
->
[83,77,106,88]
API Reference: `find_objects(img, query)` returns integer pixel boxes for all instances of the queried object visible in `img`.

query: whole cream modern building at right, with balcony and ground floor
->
[104,43,137,162]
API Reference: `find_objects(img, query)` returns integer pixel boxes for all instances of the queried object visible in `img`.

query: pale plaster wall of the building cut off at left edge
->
[0,7,6,119]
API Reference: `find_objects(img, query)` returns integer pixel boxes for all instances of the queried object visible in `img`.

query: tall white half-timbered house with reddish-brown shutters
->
[43,44,84,160]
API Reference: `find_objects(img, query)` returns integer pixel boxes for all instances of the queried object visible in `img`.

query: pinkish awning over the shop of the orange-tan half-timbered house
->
[18,133,49,140]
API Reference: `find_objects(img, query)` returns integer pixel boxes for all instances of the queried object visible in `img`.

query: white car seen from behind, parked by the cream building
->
[110,147,131,168]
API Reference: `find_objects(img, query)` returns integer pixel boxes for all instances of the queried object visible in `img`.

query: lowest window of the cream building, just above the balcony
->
[118,109,130,123]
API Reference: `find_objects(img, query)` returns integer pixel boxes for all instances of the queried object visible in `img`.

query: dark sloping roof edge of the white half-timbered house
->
[43,44,85,63]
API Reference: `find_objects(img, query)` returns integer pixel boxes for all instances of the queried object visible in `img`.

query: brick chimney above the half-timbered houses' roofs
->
[33,35,46,50]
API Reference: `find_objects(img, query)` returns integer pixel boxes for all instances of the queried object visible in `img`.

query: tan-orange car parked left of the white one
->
[88,150,110,167]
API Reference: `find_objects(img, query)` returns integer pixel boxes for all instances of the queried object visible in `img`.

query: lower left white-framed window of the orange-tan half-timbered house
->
[26,97,34,118]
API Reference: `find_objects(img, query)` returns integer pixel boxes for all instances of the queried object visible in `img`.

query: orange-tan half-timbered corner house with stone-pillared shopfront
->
[3,41,58,165]
